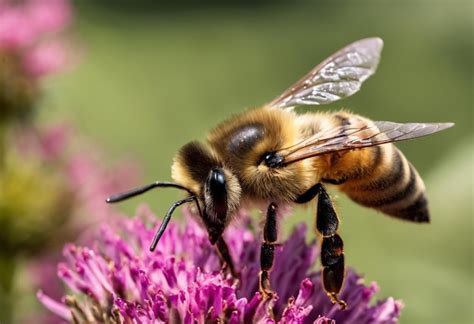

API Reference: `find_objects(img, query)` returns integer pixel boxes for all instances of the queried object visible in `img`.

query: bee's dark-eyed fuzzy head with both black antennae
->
[106,142,241,251]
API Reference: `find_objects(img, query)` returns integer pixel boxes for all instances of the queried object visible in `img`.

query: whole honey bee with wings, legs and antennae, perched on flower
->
[106,37,453,308]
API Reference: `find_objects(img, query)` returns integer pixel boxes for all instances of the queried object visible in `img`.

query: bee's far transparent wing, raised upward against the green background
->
[270,37,383,108]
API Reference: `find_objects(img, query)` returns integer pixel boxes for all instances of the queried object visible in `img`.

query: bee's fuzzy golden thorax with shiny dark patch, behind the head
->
[208,107,315,202]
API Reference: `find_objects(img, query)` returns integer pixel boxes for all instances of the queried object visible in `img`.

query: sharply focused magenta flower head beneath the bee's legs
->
[38,207,402,323]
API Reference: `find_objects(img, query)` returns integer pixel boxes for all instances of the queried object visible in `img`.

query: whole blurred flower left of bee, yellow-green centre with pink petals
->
[0,124,140,318]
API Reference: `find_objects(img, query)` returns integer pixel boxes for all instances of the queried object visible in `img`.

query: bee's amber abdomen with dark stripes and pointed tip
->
[336,144,429,222]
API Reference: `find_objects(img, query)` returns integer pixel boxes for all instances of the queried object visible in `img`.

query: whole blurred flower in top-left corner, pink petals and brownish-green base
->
[0,0,71,122]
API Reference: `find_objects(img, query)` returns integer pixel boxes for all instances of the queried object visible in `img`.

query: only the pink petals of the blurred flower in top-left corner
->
[0,0,72,77]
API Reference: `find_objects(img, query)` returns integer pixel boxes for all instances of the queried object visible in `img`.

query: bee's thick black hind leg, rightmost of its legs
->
[316,185,347,309]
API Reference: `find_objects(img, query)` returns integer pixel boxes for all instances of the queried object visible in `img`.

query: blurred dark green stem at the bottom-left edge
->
[0,256,16,324]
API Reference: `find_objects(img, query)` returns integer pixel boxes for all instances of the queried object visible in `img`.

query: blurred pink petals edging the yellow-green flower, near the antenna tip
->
[11,123,141,223]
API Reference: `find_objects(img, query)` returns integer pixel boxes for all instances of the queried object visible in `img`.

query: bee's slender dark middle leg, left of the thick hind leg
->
[258,203,278,298]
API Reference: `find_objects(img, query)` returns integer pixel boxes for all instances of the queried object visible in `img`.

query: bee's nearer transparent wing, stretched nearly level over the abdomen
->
[277,121,454,164]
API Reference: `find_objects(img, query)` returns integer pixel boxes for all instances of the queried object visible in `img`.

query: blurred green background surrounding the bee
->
[41,0,474,323]
